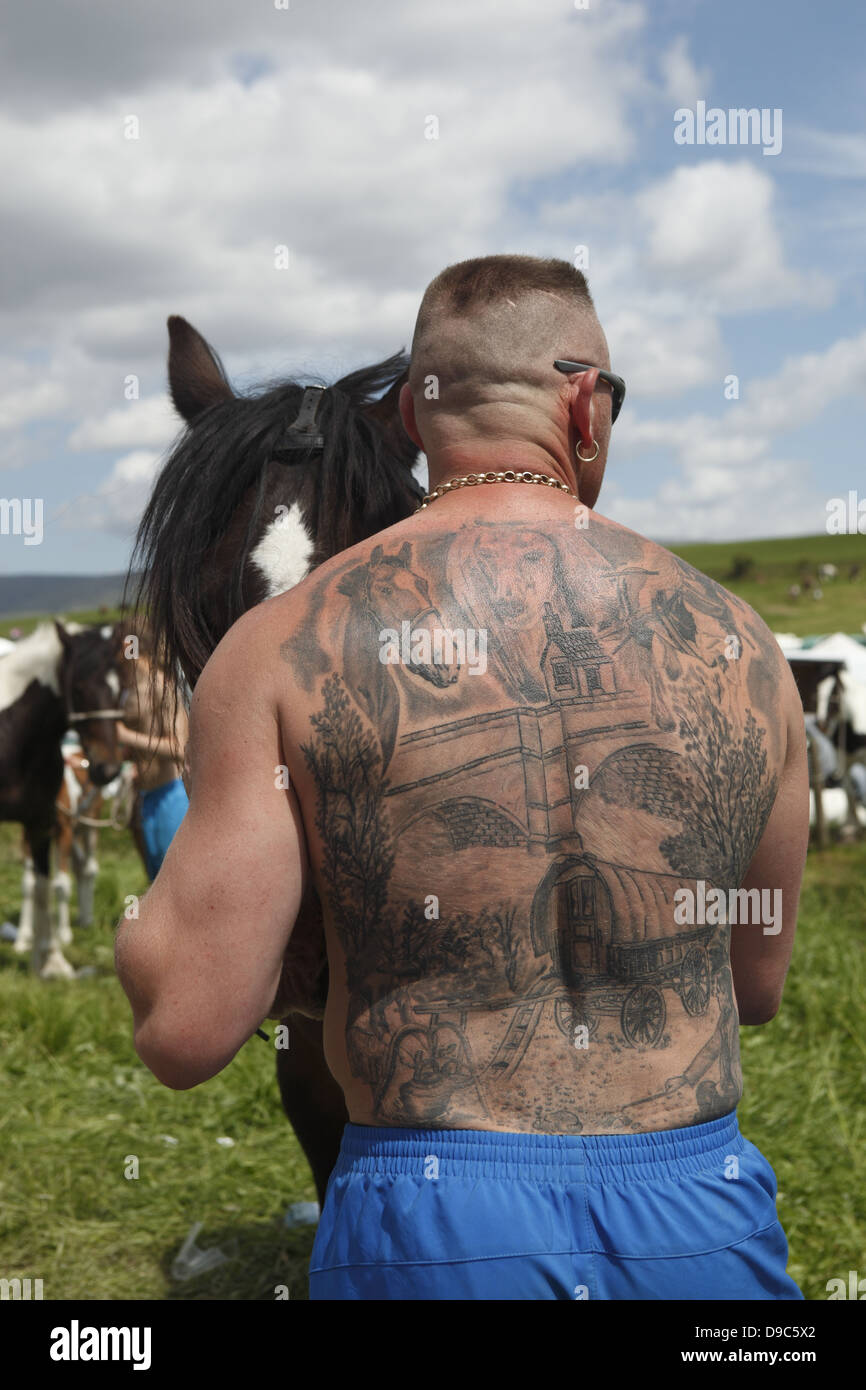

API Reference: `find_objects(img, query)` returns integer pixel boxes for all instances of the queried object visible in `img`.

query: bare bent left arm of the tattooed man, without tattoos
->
[115,613,307,1090]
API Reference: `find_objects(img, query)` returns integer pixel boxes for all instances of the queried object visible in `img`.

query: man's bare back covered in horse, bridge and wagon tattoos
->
[294,518,781,1133]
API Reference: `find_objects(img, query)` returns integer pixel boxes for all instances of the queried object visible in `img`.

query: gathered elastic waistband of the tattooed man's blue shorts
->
[334,1111,746,1183]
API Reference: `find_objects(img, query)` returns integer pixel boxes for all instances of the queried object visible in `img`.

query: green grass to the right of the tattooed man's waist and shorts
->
[740,841,866,1298]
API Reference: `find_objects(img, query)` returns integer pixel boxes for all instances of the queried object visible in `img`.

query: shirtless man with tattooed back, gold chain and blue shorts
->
[117,256,808,1300]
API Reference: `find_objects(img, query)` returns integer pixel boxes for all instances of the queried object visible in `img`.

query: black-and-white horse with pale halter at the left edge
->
[0,623,122,980]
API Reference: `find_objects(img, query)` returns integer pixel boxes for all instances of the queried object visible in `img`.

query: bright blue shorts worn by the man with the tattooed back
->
[310,1111,803,1300]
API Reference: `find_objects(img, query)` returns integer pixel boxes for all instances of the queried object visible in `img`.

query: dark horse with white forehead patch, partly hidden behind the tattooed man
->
[131,316,421,1202]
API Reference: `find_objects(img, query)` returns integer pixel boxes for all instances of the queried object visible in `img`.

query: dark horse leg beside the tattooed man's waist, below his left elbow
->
[277,1013,349,1207]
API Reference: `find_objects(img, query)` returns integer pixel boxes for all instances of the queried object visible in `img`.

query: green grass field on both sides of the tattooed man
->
[0,826,866,1300]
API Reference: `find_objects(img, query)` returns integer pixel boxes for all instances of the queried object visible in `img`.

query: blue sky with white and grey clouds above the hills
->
[0,0,866,574]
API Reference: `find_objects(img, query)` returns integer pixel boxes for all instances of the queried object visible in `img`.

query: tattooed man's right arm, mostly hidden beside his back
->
[731,662,809,1024]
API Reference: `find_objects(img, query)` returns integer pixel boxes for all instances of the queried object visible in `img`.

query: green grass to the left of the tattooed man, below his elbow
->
[0,826,316,1300]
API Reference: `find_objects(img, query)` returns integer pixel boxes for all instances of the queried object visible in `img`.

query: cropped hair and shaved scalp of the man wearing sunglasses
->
[409,256,607,421]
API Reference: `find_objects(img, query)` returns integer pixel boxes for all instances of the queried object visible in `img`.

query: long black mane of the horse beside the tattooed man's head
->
[124,352,421,685]
